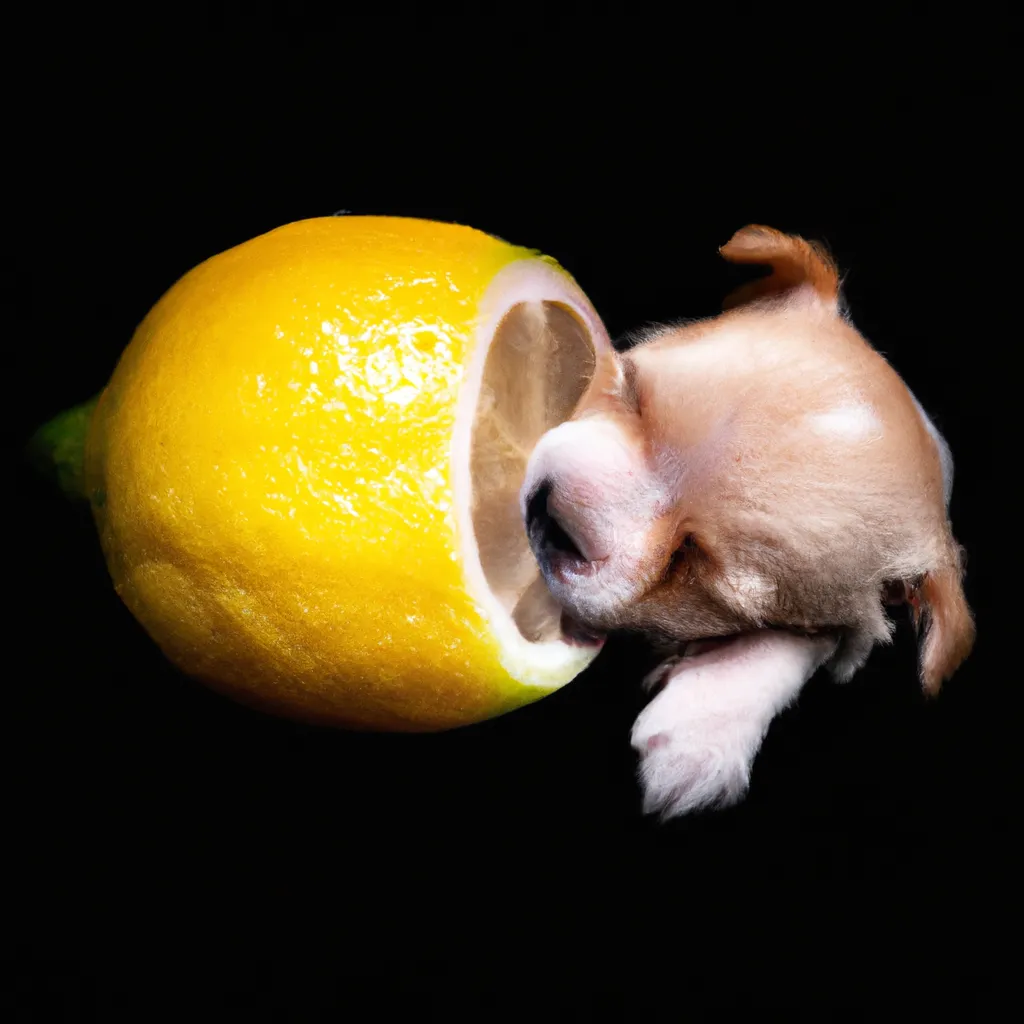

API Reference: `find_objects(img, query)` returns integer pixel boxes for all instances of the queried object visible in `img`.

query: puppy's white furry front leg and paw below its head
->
[632,630,835,818]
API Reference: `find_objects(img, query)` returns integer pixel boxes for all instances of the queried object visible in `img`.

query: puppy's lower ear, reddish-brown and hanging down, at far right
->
[909,552,975,696]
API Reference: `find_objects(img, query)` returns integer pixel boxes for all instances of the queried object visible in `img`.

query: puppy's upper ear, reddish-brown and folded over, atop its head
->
[719,224,839,309]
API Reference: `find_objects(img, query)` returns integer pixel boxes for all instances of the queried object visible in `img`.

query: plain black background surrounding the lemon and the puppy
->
[3,6,1020,1020]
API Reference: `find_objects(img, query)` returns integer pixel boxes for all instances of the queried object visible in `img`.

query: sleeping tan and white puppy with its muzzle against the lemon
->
[520,225,974,817]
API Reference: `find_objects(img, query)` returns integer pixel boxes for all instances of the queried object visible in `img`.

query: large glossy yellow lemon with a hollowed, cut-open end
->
[41,217,610,730]
